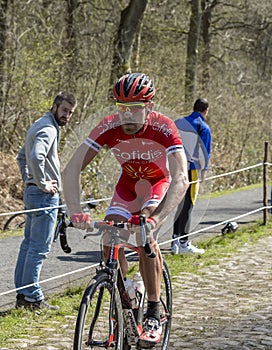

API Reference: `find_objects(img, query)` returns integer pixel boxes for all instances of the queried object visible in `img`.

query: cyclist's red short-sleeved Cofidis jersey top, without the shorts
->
[85,111,183,182]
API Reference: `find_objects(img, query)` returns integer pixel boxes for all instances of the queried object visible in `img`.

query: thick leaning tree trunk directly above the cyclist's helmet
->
[110,0,148,84]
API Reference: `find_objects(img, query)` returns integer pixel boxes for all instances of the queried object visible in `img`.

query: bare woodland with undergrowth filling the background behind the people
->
[0,0,272,224]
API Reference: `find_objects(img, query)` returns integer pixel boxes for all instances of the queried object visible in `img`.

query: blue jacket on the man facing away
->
[175,112,212,170]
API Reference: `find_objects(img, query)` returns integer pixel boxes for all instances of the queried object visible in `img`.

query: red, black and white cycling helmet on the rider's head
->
[113,73,155,102]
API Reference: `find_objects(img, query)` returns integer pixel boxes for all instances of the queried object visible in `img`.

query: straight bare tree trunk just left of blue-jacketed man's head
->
[185,0,201,108]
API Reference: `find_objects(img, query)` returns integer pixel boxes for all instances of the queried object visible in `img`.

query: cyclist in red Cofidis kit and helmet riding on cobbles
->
[63,73,189,346]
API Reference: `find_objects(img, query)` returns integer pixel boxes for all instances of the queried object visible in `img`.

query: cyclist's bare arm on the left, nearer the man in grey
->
[62,143,97,216]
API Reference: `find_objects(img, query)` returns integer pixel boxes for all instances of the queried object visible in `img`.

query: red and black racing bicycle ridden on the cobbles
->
[73,216,172,350]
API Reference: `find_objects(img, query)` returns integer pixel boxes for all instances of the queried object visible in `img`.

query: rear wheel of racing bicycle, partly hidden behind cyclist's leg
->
[123,260,172,350]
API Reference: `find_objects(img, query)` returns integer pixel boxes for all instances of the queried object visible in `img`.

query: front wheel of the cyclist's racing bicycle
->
[73,273,123,350]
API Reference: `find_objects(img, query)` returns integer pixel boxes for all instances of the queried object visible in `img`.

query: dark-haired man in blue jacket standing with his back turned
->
[171,98,212,254]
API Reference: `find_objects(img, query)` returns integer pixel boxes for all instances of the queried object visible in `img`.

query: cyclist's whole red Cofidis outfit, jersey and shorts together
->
[85,112,183,219]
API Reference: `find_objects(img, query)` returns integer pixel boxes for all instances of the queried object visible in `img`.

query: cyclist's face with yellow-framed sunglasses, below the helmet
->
[116,101,151,135]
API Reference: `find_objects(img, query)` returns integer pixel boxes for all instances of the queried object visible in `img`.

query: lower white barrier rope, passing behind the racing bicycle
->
[0,205,272,296]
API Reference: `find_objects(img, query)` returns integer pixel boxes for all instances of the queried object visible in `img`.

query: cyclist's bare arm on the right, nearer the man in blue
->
[151,151,189,225]
